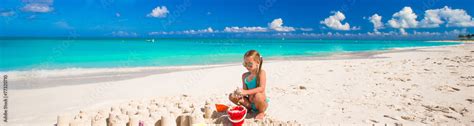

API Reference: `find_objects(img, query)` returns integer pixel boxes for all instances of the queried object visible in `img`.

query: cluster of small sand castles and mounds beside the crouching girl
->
[56,96,300,126]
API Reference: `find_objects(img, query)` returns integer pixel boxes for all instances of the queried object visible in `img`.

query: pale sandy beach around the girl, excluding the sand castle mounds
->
[6,43,474,126]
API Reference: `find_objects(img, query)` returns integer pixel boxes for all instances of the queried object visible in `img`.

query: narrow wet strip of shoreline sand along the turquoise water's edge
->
[5,43,470,90]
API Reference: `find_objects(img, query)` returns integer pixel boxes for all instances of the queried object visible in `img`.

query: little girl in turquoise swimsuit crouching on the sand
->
[229,50,268,119]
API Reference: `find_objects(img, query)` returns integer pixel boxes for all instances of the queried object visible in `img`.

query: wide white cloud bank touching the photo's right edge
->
[420,6,474,28]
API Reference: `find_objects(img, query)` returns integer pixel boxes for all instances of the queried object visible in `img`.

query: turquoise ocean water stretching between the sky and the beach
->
[0,38,459,71]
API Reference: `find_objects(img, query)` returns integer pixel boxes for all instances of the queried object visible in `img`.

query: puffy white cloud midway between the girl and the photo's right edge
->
[320,11,360,31]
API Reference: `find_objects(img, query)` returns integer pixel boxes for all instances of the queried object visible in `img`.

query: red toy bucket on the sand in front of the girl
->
[227,106,247,126]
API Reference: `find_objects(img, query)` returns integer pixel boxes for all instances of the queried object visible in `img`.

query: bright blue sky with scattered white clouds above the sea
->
[0,0,474,39]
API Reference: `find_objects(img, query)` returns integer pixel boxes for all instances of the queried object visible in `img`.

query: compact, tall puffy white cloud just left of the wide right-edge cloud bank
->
[388,7,418,34]
